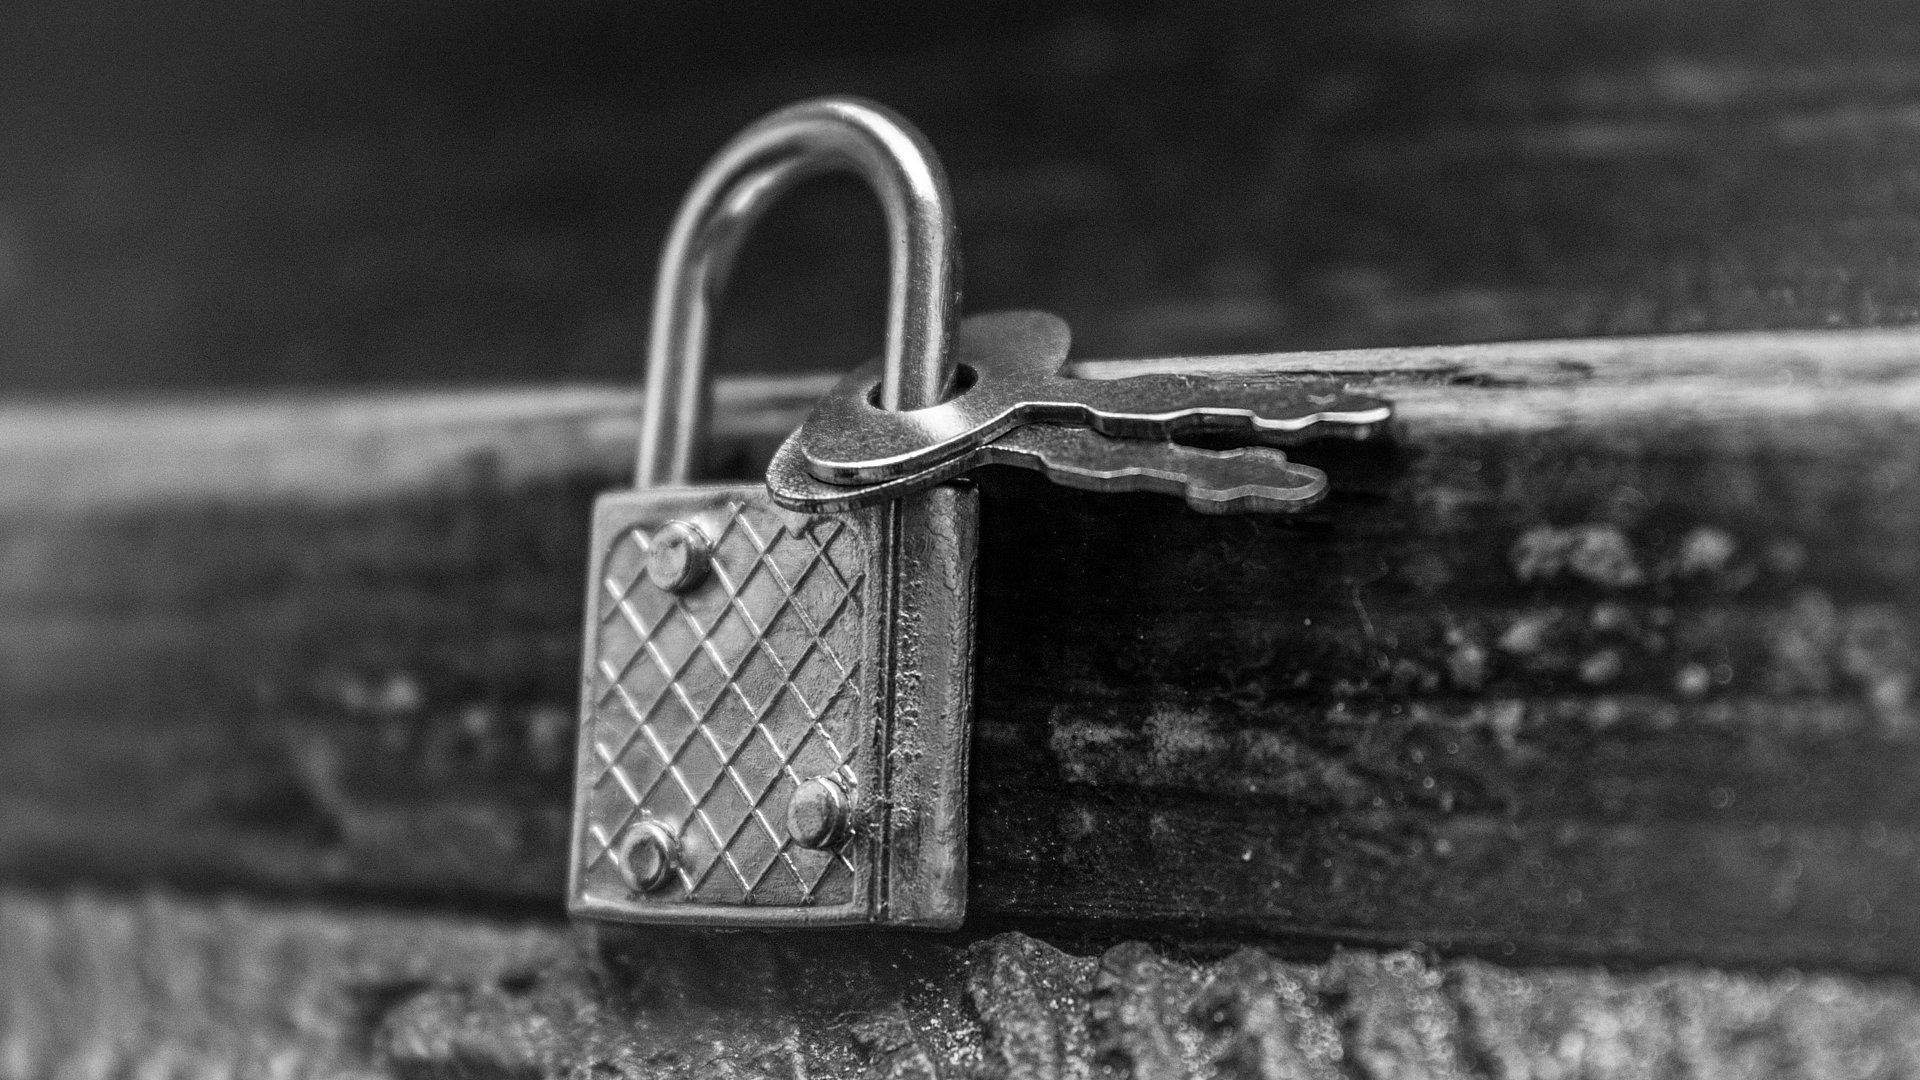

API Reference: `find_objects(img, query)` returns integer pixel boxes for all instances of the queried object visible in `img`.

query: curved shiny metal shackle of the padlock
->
[634,98,960,488]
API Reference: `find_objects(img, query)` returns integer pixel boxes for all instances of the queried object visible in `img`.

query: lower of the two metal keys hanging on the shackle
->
[766,425,1327,513]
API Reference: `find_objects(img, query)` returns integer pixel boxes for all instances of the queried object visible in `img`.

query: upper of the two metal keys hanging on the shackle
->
[799,311,1388,486]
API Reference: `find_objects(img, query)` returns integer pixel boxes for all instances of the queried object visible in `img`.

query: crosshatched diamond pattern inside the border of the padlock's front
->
[582,502,868,905]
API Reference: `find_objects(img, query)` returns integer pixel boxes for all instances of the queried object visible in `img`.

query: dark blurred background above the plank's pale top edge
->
[11,0,1920,394]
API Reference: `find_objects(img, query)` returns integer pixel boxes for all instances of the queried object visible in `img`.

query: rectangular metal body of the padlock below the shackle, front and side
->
[568,486,972,926]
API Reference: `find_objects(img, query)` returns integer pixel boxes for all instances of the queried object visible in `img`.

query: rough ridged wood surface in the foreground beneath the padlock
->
[11,890,1920,1080]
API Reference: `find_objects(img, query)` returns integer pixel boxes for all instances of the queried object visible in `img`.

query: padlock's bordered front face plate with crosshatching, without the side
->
[570,486,887,926]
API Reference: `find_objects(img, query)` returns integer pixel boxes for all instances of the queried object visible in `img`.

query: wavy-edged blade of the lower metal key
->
[981,425,1327,513]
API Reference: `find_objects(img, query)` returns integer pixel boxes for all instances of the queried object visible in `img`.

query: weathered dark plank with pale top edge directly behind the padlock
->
[0,331,1920,972]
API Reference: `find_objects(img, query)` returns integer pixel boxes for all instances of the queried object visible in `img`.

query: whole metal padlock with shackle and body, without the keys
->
[568,98,979,928]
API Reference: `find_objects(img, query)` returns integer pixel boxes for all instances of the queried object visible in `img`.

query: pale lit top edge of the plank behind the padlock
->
[11,329,1920,515]
